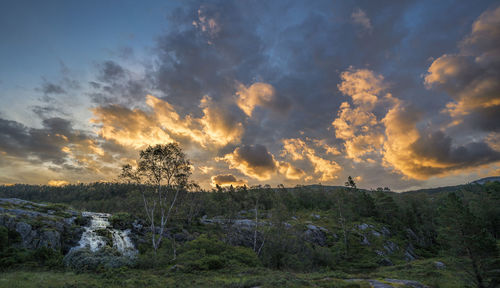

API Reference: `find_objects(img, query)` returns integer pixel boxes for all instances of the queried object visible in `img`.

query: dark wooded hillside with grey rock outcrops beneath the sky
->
[0,182,500,287]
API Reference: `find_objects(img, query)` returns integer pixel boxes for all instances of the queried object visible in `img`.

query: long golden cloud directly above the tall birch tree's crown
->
[91,95,243,149]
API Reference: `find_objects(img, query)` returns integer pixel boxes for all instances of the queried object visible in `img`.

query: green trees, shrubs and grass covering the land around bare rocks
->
[0,182,500,287]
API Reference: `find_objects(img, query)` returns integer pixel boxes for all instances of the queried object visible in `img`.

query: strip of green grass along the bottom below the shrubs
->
[0,259,467,288]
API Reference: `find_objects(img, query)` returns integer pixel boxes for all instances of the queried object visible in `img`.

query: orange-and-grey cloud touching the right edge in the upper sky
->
[425,7,500,120]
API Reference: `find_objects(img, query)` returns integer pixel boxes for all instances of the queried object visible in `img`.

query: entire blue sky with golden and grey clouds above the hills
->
[0,0,500,191]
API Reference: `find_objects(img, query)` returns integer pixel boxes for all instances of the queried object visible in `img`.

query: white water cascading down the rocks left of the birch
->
[73,212,137,256]
